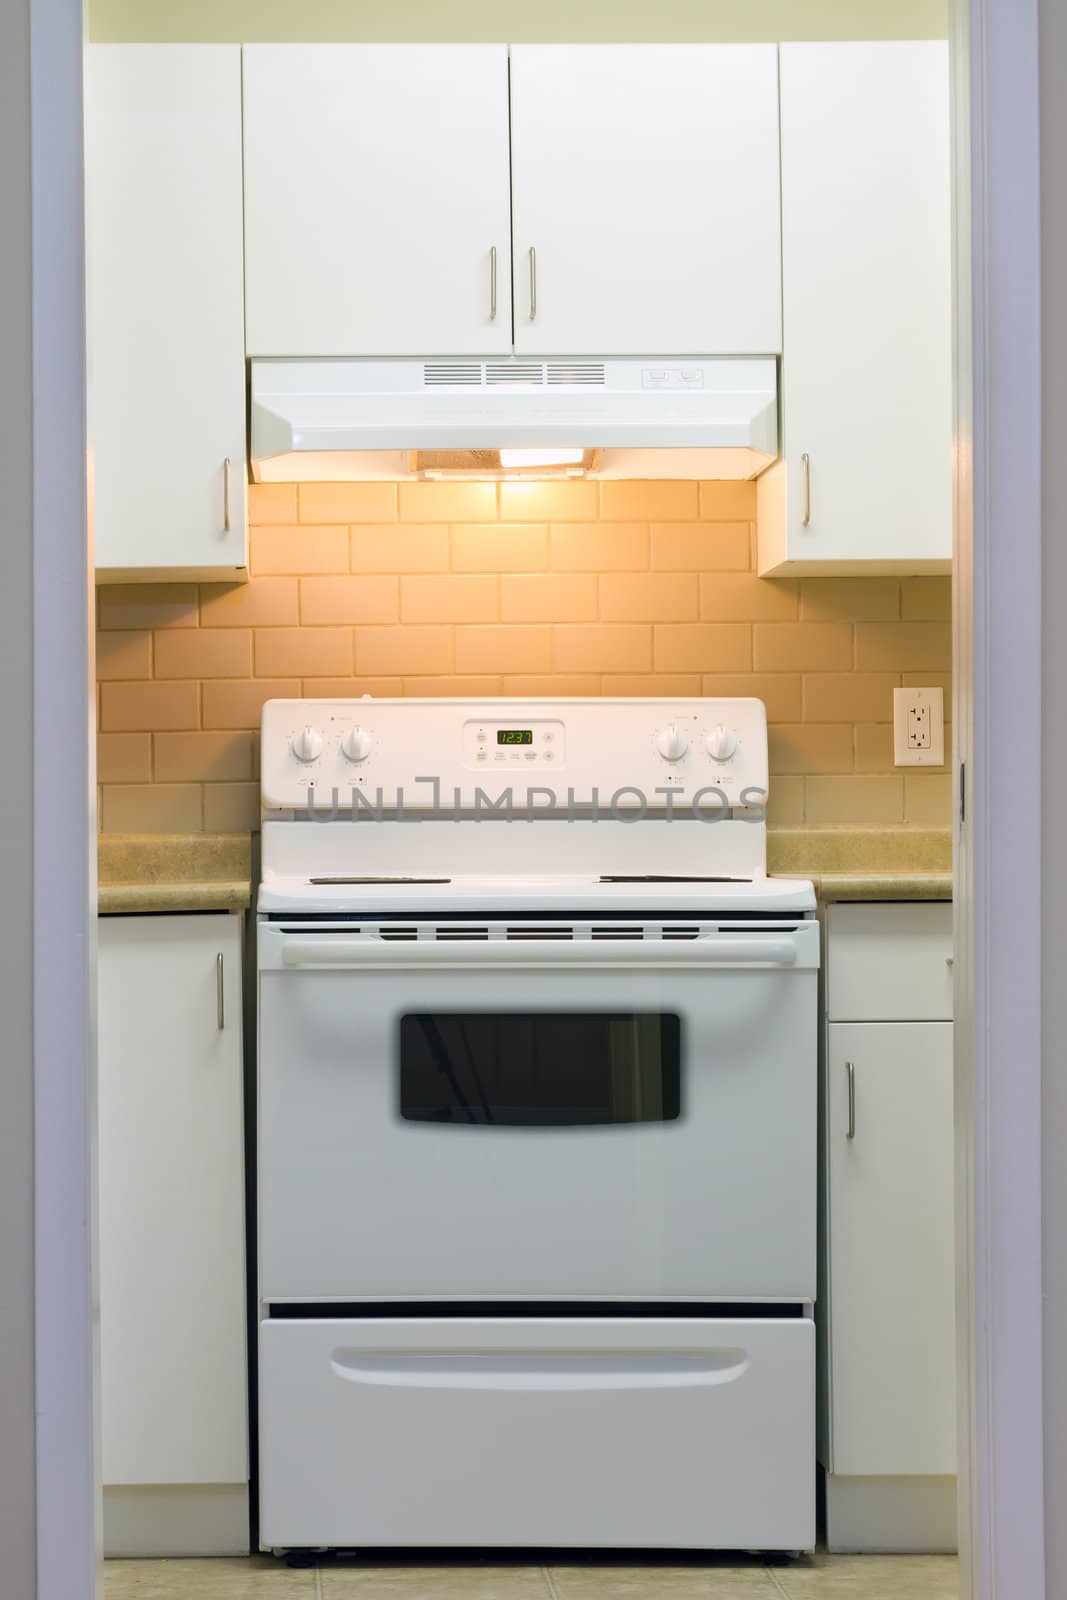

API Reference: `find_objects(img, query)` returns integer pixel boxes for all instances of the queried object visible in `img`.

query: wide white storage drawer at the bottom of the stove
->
[259,1317,814,1549]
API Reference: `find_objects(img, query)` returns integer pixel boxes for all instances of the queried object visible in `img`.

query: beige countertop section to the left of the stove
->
[98,834,251,914]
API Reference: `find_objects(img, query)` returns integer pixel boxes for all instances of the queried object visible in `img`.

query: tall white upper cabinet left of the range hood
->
[86,45,248,581]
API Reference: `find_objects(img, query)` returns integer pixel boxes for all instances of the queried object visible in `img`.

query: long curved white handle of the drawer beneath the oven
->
[330,1349,749,1392]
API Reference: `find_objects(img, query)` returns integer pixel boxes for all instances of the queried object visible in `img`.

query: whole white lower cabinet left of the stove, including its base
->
[98,912,250,1555]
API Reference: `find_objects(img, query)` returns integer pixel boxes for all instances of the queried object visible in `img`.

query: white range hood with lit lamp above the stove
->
[251,355,777,483]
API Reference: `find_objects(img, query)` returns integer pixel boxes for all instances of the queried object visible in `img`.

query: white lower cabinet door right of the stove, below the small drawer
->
[827,1022,957,1477]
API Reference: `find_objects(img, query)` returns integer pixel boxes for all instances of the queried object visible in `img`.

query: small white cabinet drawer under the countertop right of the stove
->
[827,901,952,1022]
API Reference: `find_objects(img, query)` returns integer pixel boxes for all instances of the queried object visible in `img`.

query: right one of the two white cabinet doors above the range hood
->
[512,45,782,355]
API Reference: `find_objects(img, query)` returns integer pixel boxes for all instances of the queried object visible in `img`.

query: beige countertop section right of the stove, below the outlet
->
[766,827,952,901]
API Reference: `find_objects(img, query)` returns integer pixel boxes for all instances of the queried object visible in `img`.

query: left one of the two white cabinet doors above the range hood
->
[245,45,512,355]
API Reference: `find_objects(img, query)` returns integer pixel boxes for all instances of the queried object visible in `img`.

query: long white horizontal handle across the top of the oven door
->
[282,934,798,973]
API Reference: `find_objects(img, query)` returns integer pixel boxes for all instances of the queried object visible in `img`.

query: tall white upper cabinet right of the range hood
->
[758,40,952,574]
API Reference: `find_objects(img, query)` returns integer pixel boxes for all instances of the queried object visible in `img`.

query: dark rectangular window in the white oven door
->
[400,1011,681,1128]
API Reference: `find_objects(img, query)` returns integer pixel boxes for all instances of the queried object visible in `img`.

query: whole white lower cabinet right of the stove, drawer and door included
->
[819,904,957,1550]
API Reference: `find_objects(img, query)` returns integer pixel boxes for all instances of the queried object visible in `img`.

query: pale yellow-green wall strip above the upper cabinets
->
[90,0,947,43]
